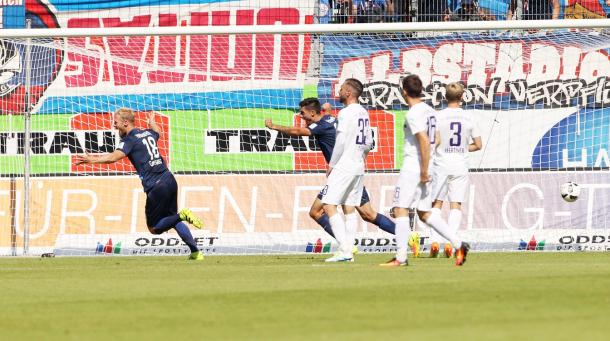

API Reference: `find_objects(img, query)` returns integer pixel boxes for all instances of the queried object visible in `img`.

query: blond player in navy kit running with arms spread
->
[75,108,203,260]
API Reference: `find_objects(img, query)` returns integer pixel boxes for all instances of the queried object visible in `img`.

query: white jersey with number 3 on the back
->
[434,108,481,175]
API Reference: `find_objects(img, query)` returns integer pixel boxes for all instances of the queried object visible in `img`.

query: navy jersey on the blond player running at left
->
[117,129,169,193]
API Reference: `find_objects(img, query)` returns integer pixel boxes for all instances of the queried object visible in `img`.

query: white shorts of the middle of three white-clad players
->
[393,172,432,212]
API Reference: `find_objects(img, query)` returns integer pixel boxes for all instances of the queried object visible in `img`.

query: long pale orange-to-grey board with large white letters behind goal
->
[0,171,610,253]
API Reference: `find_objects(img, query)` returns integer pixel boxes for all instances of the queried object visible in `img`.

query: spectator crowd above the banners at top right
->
[321,0,610,23]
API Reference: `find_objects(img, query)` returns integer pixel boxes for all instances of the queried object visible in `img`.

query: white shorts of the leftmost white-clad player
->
[321,169,364,206]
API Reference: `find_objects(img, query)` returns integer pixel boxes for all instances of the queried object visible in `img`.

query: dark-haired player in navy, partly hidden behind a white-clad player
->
[265,98,394,246]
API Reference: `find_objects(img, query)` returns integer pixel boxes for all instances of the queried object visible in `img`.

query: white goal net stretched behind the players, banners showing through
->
[0,16,610,255]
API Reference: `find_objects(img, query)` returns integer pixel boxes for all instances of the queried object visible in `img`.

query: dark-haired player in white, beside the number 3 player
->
[381,75,470,266]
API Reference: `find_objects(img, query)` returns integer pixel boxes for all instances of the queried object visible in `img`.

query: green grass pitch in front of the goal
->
[0,252,610,340]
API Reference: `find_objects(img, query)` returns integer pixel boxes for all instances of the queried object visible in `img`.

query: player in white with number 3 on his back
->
[430,83,482,257]
